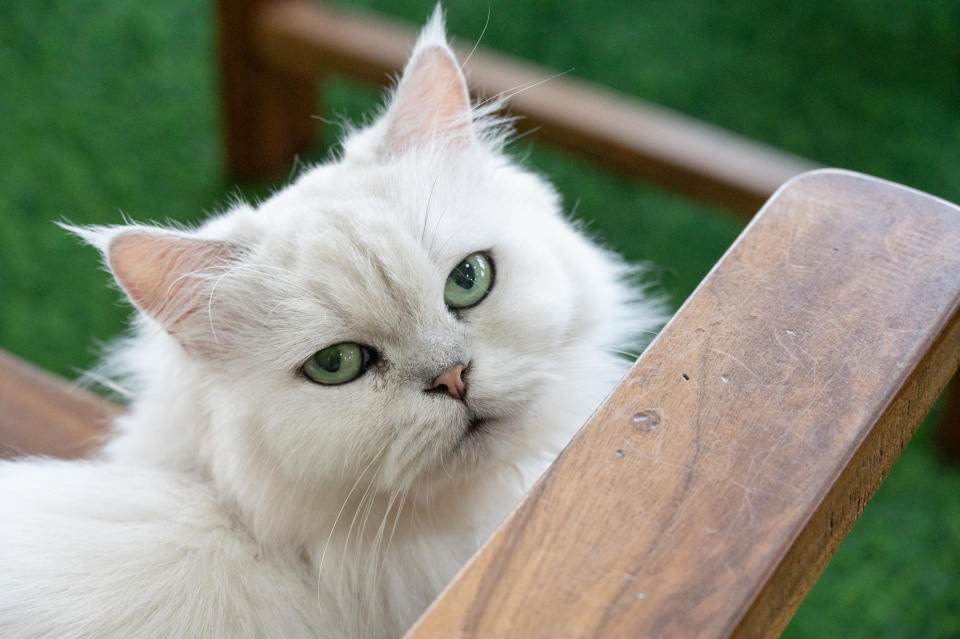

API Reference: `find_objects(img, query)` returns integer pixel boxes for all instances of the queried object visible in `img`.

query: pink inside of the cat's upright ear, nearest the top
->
[387,46,473,150]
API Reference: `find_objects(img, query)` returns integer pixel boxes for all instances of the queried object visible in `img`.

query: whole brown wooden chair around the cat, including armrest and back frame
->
[0,0,960,639]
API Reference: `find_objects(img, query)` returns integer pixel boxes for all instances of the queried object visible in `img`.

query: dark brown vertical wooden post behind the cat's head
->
[217,0,317,180]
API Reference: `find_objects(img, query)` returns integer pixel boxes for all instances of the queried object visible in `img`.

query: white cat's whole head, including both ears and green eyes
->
[86,12,654,520]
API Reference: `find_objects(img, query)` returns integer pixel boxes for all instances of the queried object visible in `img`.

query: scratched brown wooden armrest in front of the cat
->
[407,171,960,639]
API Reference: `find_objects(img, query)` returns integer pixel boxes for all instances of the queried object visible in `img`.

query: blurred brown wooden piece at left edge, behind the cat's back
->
[0,351,120,459]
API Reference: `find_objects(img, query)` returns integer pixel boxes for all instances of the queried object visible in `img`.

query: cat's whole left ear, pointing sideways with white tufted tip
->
[70,227,239,352]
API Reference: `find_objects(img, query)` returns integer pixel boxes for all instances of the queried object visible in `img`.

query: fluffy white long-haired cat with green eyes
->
[0,8,661,639]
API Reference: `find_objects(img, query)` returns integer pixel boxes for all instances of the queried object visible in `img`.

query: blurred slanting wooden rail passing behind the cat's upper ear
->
[254,0,814,217]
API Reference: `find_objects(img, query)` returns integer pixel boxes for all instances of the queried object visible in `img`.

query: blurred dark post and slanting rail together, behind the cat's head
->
[219,0,816,217]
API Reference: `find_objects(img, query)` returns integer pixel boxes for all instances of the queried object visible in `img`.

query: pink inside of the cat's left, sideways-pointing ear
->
[107,231,231,334]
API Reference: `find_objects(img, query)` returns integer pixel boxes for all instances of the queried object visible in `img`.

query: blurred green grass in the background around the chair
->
[0,0,960,638]
